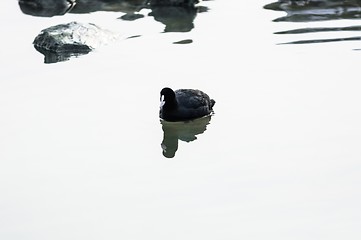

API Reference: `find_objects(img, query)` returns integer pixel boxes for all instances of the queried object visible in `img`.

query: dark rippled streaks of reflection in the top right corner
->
[264,0,361,44]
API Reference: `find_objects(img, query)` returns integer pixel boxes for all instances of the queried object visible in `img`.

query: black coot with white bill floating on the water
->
[159,87,216,122]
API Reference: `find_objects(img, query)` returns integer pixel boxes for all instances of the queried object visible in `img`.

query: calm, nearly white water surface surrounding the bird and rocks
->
[0,0,361,240]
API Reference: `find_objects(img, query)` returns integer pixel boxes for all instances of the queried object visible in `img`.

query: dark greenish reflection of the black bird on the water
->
[161,116,211,158]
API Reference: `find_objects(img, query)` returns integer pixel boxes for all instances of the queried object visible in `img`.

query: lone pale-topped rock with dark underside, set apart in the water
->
[33,22,119,63]
